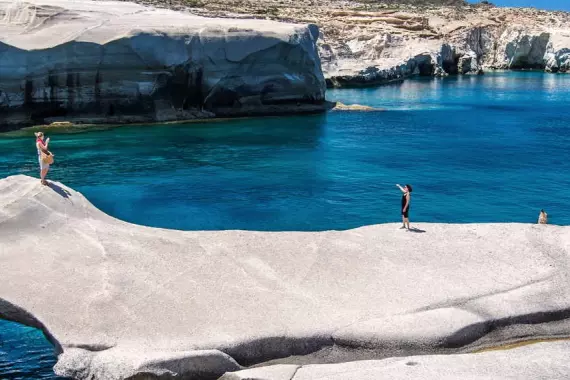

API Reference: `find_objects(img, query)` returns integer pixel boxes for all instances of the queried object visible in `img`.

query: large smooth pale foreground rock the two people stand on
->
[0,176,570,380]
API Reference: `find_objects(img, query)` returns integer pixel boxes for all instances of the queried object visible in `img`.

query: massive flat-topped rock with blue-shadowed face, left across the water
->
[0,0,325,125]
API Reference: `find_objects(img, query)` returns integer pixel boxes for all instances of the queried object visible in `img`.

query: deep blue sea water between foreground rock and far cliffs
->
[0,72,570,378]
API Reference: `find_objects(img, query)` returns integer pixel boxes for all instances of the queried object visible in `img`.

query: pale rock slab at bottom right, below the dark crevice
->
[220,342,570,380]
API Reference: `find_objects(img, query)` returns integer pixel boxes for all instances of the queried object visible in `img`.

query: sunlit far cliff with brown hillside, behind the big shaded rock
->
[151,0,570,87]
